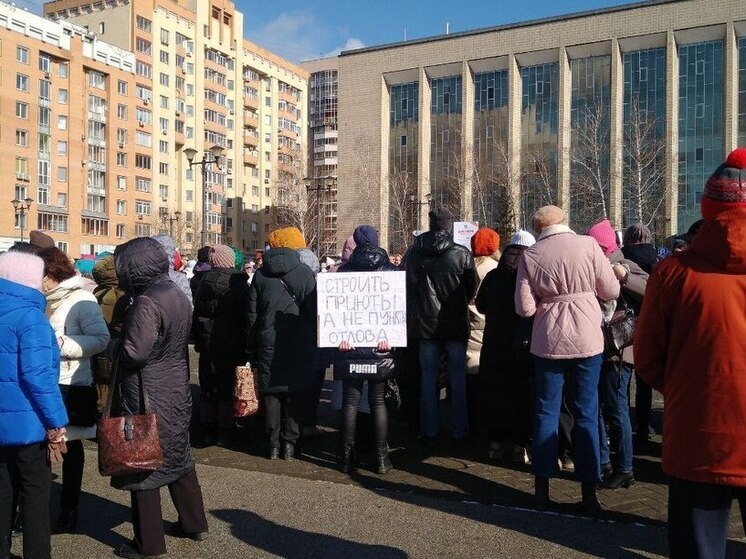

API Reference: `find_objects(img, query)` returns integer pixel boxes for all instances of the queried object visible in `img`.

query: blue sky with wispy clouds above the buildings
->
[235,0,630,62]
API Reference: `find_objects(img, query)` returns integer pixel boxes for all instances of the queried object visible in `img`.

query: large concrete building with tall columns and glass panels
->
[337,0,746,249]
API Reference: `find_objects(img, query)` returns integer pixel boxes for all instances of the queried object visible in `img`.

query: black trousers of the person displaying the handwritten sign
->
[342,379,389,454]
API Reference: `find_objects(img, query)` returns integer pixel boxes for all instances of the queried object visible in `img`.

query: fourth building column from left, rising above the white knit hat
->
[508,54,520,229]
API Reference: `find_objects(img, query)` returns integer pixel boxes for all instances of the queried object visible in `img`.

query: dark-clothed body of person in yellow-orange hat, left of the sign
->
[247,232,316,460]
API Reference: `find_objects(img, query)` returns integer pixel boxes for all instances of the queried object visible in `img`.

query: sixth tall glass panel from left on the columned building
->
[622,48,666,234]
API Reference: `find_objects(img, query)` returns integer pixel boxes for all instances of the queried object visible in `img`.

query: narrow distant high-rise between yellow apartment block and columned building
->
[301,56,339,255]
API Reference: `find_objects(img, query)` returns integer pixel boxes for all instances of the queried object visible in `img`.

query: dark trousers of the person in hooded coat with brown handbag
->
[130,470,207,555]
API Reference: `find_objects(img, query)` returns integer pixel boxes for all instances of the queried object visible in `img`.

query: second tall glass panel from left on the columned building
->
[430,76,464,216]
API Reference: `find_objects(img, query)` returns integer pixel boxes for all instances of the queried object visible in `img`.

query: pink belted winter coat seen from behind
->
[515,225,620,359]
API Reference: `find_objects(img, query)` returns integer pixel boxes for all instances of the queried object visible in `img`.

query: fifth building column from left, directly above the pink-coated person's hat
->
[557,47,572,217]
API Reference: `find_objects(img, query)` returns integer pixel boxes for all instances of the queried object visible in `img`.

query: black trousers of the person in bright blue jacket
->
[0,443,52,559]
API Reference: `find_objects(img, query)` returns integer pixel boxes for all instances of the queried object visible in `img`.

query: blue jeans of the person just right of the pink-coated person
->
[598,361,632,473]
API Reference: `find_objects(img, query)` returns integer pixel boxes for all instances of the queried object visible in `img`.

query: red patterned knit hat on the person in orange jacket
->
[701,148,746,220]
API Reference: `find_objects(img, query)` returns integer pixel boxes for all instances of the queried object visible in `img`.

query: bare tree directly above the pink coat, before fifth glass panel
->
[570,99,611,231]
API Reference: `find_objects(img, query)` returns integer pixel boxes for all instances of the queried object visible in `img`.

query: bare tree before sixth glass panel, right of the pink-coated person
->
[623,97,666,235]
